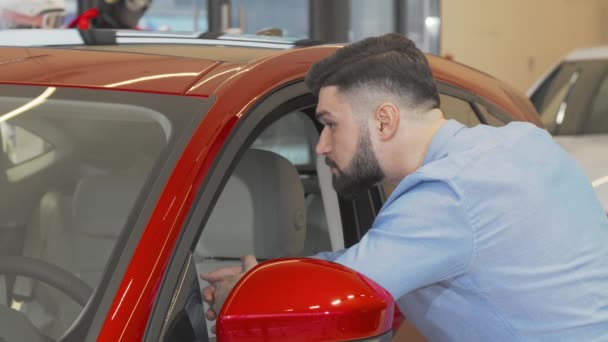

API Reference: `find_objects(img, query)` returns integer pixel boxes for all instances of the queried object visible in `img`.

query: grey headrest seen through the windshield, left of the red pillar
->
[72,174,145,237]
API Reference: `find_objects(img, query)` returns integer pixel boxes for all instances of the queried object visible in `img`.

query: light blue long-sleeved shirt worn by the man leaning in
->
[318,121,608,342]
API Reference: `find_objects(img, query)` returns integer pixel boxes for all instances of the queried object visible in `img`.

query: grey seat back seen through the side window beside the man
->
[195,149,306,259]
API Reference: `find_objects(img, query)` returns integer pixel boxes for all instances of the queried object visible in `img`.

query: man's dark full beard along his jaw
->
[325,127,384,199]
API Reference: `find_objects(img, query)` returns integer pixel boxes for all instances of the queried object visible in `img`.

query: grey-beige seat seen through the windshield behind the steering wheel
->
[13,173,143,338]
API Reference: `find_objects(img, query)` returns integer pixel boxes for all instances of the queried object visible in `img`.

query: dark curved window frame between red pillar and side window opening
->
[144,80,316,341]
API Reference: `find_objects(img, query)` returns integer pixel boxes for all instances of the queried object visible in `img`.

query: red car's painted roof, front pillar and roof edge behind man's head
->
[0,42,542,341]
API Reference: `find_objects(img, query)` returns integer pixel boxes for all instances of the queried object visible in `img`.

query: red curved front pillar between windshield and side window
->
[99,47,346,341]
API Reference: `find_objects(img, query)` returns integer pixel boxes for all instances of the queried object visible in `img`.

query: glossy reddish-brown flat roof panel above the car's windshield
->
[0,48,219,95]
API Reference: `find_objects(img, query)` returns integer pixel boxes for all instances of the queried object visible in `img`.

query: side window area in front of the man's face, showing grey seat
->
[193,111,344,339]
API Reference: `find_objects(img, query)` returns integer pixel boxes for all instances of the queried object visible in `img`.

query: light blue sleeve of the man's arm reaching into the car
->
[334,180,474,300]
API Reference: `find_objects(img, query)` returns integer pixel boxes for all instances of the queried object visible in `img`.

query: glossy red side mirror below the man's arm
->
[216,259,395,341]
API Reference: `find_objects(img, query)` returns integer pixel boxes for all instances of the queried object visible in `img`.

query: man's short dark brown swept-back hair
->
[306,33,439,109]
